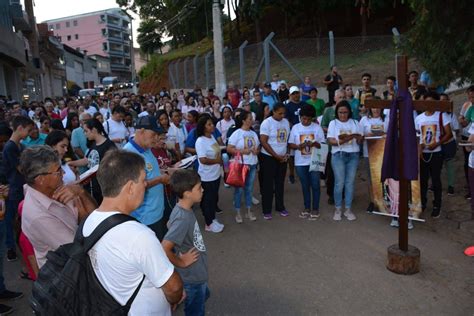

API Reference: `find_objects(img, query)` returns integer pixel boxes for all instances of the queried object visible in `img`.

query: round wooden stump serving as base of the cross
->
[387,244,420,275]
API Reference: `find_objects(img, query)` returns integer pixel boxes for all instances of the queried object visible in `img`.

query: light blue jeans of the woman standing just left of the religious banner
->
[331,151,359,209]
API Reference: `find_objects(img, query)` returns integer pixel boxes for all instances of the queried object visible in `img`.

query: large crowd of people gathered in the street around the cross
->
[0,66,474,315]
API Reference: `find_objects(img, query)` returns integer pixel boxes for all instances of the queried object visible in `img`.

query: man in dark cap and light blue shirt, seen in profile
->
[123,116,170,241]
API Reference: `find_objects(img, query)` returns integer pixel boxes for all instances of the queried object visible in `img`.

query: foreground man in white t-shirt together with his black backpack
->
[31,150,183,316]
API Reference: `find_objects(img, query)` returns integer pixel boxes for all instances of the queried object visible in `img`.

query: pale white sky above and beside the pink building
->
[33,0,140,47]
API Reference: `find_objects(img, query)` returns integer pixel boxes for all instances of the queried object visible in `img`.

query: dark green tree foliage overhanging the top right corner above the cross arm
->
[404,0,474,85]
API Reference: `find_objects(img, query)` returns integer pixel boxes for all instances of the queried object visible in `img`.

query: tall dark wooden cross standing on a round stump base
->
[365,55,453,274]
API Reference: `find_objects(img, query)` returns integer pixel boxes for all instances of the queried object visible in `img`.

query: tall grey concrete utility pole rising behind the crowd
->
[212,0,227,97]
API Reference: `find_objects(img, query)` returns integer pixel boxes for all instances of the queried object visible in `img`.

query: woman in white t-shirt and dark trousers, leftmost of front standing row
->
[196,115,224,233]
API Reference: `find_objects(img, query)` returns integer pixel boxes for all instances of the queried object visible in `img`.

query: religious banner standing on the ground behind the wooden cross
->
[367,137,421,220]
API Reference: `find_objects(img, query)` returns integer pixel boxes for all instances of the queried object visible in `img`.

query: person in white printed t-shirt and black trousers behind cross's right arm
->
[415,92,453,218]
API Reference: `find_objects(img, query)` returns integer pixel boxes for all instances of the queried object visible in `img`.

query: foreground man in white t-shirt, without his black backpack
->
[82,151,183,316]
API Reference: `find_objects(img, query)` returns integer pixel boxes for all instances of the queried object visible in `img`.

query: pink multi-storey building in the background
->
[44,8,133,81]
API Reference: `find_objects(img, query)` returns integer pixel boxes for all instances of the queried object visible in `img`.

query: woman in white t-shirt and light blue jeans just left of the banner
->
[327,100,364,221]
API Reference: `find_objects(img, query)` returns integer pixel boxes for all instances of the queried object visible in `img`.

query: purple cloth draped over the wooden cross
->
[382,90,419,182]
